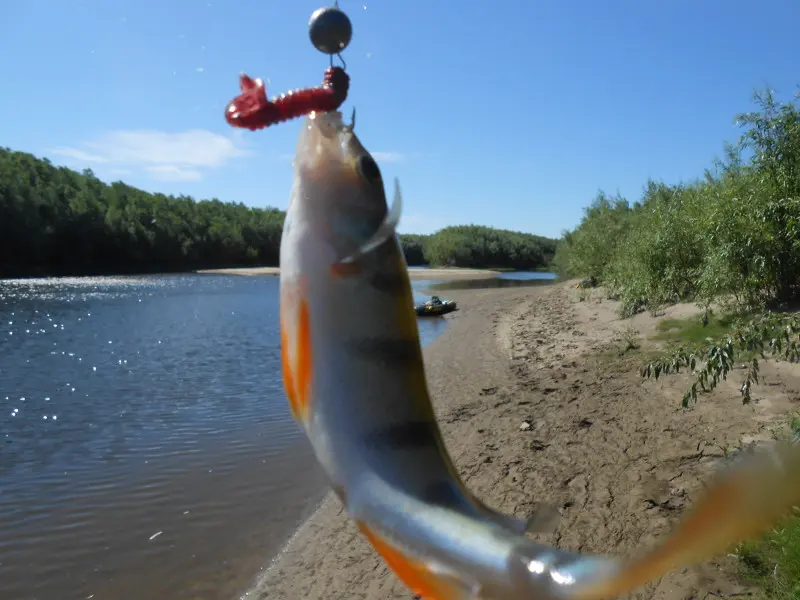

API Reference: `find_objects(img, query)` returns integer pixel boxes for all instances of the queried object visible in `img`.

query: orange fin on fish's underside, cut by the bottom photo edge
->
[357,521,480,600]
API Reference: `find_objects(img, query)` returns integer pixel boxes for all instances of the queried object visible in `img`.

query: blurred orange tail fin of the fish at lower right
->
[573,445,800,600]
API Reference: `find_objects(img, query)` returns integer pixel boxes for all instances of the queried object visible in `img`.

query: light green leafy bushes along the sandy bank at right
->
[554,91,800,315]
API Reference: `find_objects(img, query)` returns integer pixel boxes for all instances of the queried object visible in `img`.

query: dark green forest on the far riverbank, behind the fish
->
[0,148,556,277]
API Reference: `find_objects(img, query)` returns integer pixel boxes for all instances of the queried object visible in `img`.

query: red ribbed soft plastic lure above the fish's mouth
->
[225,67,350,131]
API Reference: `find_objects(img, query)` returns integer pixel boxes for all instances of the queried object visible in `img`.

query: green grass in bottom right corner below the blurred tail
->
[737,414,800,600]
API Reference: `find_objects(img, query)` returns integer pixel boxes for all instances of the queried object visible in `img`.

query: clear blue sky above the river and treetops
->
[0,0,800,236]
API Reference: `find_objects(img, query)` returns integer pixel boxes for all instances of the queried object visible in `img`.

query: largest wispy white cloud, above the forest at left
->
[50,129,249,181]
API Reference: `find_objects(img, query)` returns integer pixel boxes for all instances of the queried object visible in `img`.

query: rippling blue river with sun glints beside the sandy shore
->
[0,275,445,600]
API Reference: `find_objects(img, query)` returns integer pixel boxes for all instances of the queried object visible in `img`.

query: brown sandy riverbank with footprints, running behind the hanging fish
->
[249,282,800,600]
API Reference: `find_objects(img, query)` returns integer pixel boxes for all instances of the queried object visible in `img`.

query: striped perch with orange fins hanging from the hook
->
[279,111,800,600]
